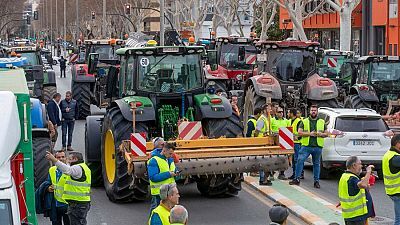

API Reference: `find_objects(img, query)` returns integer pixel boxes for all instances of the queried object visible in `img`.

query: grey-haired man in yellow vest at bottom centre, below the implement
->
[148,183,180,225]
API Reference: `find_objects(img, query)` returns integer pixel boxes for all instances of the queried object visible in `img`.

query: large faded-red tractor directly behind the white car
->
[243,40,339,124]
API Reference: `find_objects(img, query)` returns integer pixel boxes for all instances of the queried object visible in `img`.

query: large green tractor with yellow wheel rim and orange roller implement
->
[85,43,287,202]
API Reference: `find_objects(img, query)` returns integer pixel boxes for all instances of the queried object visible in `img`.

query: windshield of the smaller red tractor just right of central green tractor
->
[220,43,257,70]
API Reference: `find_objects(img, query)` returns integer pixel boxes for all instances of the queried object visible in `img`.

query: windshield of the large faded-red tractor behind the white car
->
[266,48,315,81]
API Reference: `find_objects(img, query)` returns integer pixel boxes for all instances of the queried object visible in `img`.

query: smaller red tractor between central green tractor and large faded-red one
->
[206,37,257,95]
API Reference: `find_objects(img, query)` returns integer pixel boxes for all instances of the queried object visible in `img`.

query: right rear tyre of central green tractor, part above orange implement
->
[203,113,243,138]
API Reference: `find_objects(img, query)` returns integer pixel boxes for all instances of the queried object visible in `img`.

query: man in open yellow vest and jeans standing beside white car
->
[289,105,328,188]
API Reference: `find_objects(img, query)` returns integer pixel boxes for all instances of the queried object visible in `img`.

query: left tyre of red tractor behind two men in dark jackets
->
[72,82,93,119]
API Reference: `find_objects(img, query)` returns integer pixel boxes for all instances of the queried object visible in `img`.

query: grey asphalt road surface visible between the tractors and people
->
[38,62,394,225]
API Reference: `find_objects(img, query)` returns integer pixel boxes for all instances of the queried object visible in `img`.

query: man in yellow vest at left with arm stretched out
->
[46,151,92,225]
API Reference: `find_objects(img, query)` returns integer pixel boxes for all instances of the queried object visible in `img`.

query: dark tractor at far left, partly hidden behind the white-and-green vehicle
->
[9,46,57,102]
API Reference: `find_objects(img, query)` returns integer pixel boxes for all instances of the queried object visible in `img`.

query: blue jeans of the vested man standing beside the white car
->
[295,146,322,182]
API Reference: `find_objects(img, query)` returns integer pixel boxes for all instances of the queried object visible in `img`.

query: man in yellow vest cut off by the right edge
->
[382,134,400,225]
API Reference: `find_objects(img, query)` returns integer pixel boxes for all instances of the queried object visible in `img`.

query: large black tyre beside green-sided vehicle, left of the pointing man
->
[32,137,51,189]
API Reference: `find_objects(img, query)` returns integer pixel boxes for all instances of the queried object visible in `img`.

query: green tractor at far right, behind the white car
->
[344,55,400,114]
